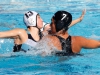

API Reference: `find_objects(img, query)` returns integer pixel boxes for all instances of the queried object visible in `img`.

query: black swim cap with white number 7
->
[53,11,72,32]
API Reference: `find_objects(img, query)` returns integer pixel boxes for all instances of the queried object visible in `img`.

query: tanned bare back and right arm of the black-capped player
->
[47,35,100,53]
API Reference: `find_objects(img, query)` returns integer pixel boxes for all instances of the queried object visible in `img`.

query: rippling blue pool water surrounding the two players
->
[0,0,100,75]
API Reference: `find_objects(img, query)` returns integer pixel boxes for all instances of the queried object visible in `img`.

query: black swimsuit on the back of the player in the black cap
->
[56,36,74,56]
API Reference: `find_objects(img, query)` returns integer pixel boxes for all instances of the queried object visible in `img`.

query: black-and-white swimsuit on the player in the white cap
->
[13,31,43,52]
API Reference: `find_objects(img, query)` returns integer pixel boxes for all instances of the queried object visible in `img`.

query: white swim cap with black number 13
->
[24,11,38,26]
